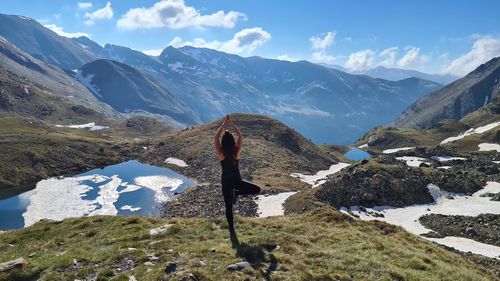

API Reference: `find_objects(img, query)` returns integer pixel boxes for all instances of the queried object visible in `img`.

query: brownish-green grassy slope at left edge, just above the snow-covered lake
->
[0,117,133,190]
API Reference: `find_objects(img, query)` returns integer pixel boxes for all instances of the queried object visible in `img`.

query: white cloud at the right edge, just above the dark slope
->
[443,36,500,76]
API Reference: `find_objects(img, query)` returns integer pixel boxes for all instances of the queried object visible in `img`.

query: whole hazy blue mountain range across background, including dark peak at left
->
[0,12,441,143]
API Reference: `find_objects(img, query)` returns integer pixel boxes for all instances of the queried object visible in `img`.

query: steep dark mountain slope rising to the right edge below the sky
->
[394,57,500,129]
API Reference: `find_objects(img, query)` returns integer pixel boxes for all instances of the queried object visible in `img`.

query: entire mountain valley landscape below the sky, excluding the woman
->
[0,7,500,281]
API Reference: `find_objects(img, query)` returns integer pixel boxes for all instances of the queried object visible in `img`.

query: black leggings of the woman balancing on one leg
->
[222,180,260,233]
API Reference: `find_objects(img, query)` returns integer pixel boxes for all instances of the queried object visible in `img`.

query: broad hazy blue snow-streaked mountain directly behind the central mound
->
[159,47,440,143]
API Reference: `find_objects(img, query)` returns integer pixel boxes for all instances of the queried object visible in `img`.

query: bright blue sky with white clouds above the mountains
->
[0,0,500,75]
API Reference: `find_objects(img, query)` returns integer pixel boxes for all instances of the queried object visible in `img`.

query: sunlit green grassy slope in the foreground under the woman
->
[0,208,494,281]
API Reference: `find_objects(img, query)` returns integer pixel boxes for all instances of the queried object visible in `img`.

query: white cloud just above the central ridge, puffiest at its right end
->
[169,27,271,54]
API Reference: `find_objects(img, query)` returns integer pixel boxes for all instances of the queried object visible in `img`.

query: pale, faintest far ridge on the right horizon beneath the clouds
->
[322,64,459,85]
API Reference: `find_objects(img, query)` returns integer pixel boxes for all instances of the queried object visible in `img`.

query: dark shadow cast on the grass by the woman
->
[231,234,278,280]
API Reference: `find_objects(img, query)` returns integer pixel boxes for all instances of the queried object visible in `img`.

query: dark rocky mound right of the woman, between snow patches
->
[285,150,500,212]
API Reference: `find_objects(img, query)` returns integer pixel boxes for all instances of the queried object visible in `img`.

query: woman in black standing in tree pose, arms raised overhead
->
[215,115,260,238]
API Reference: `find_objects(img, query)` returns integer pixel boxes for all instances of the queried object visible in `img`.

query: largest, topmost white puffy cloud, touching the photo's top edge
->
[117,0,246,29]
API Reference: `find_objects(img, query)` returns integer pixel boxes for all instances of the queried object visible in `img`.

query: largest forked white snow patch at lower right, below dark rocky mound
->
[341,182,500,258]
